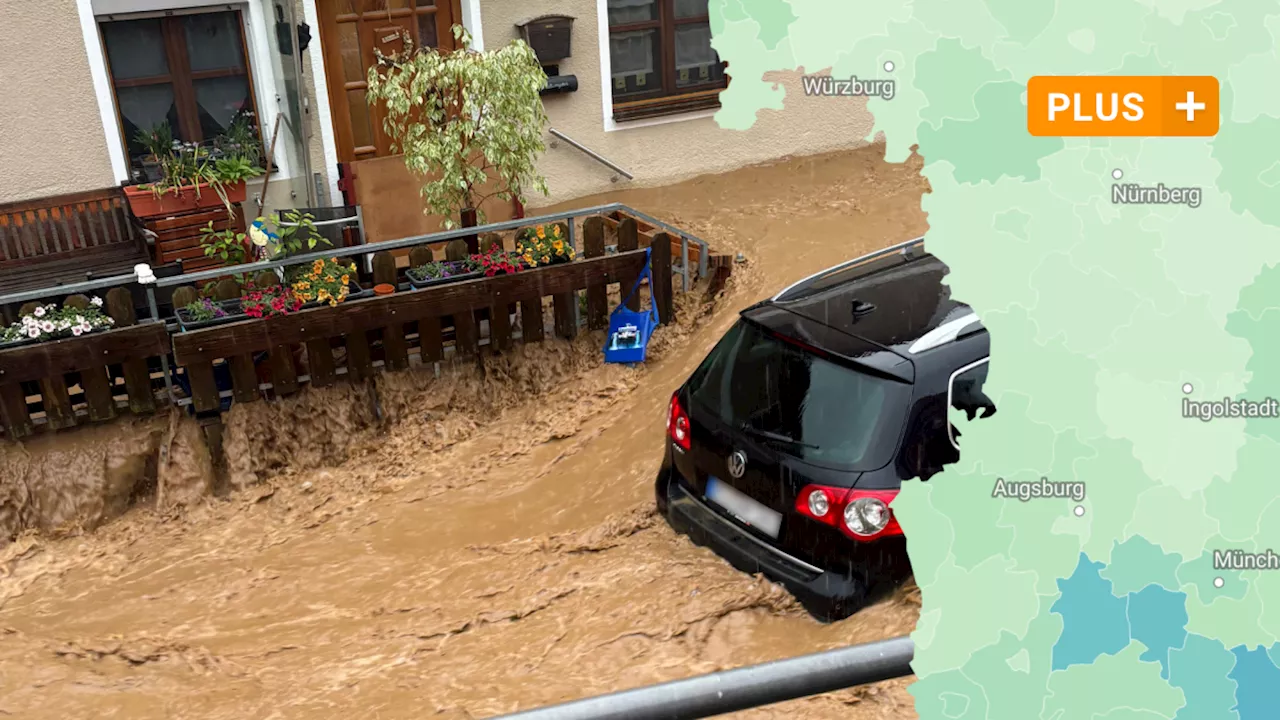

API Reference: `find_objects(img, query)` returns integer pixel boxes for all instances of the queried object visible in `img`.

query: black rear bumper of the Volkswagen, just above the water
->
[655,468,868,619]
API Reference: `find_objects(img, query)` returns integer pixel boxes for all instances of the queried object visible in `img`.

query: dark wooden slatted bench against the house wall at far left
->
[0,187,151,295]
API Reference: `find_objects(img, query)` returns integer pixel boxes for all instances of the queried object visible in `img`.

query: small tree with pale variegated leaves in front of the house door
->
[367,26,547,254]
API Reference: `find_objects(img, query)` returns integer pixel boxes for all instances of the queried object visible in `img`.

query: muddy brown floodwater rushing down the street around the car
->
[0,146,928,720]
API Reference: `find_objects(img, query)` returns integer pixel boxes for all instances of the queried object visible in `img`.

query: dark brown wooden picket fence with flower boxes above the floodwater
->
[0,217,673,439]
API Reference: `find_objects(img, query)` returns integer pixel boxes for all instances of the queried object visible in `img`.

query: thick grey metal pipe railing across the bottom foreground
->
[483,637,915,720]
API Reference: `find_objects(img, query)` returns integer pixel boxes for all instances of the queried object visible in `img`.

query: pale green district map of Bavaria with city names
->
[709,0,1280,720]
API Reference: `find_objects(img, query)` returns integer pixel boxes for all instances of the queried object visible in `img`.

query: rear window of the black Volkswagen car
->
[687,320,911,470]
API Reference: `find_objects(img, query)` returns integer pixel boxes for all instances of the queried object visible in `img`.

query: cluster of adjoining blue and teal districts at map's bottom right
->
[1050,541,1280,720]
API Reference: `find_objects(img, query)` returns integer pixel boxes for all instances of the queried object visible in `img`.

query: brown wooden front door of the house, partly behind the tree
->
[317,0,462,163]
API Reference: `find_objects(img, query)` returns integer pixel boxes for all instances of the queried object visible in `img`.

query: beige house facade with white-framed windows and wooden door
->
[0,0,872,220]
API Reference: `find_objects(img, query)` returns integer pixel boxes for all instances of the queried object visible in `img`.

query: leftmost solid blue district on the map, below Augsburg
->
[1050,552,1131,670]
